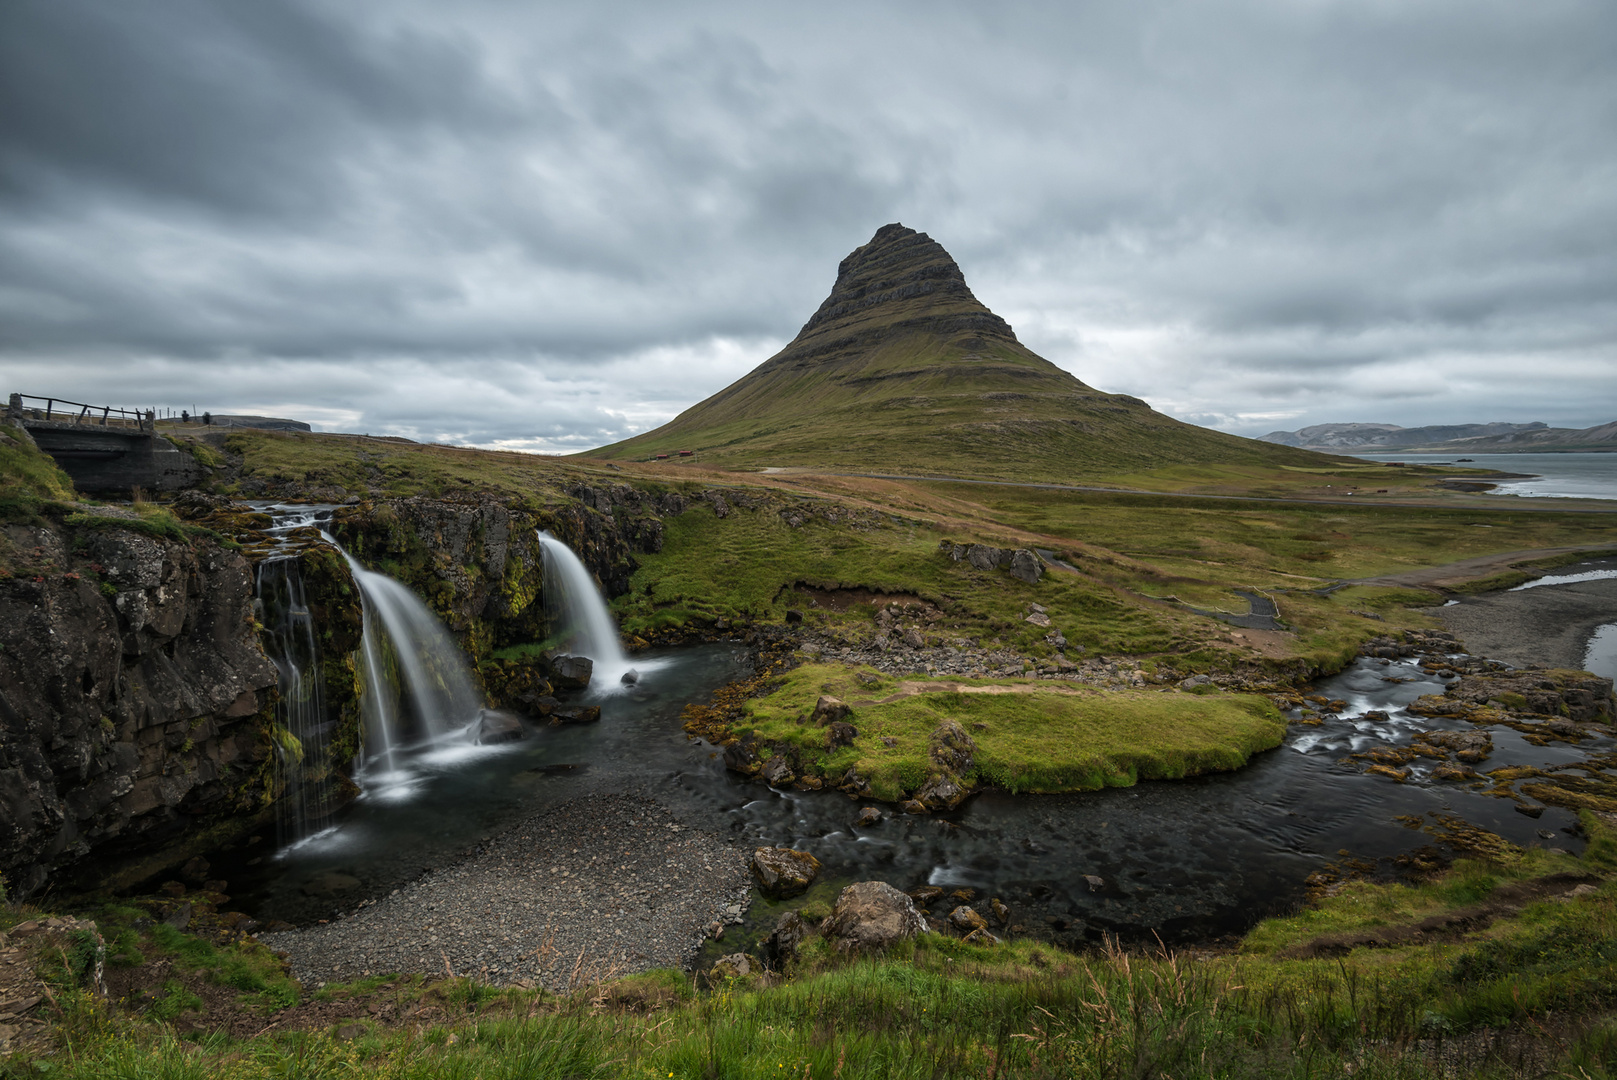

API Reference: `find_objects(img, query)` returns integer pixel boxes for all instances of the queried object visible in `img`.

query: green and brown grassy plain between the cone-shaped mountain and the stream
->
[208,432,1617,669]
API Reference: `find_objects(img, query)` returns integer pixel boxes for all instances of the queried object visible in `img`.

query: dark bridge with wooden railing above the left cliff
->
[5,394,205,495]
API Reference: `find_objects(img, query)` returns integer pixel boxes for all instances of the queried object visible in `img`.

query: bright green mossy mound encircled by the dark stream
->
[736,664,1286,800]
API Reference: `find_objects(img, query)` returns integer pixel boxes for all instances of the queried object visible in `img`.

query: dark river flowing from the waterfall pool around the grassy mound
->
[210,643,1609,944]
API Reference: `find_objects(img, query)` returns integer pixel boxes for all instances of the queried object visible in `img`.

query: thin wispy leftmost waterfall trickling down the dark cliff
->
[257,558,331,844]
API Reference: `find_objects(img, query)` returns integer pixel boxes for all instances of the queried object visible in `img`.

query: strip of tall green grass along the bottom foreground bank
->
[9,815,1617,1080]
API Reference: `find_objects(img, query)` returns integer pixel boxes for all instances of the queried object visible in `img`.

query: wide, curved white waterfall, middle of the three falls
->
[341,552,482,770]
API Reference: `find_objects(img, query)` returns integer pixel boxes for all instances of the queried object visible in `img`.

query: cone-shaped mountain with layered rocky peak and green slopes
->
[587,225,1321,480]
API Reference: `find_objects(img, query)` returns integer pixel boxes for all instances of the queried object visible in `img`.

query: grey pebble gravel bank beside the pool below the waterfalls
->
[259,794,752,991]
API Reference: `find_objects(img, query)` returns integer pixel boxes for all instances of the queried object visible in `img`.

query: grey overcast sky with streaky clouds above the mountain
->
[0,0,1617,451]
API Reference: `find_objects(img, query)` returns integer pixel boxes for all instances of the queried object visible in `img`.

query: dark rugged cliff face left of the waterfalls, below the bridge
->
[0,511,275,896]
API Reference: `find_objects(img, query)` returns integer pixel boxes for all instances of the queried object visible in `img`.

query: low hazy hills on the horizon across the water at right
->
[1260,422,1617,454]
